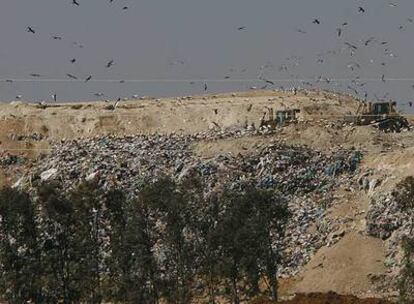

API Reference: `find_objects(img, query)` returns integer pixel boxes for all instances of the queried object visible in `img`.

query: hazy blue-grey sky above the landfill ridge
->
[0,0,414,108]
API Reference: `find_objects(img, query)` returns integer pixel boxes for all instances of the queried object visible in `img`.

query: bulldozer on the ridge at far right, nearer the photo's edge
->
[353,101,410,132]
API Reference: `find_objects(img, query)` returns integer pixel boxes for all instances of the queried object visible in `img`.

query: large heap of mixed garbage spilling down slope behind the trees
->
[15,131,361,276]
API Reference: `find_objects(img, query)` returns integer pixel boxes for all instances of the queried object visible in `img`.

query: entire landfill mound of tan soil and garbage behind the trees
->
[0,90,414,304]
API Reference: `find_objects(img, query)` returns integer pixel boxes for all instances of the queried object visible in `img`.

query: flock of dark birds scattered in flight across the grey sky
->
[2,0,414,107]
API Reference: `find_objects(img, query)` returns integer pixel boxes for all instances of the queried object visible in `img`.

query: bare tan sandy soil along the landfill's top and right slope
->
[0,91,414,303]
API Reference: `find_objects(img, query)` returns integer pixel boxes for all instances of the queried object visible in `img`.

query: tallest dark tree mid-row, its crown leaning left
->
[139,178,196,303]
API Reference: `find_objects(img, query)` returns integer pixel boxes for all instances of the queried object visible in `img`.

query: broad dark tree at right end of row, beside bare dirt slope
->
[215,187,289,304]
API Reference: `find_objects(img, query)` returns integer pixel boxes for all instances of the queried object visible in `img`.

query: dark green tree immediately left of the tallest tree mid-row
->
[105,190,159,304]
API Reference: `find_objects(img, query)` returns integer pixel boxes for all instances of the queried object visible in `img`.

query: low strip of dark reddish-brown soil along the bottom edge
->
[251,292,391,304]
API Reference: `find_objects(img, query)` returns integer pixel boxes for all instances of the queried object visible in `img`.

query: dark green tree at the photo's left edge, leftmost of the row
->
[0,188,43,303]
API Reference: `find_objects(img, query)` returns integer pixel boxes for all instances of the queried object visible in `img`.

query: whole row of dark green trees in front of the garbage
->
[0,178,289,304]
